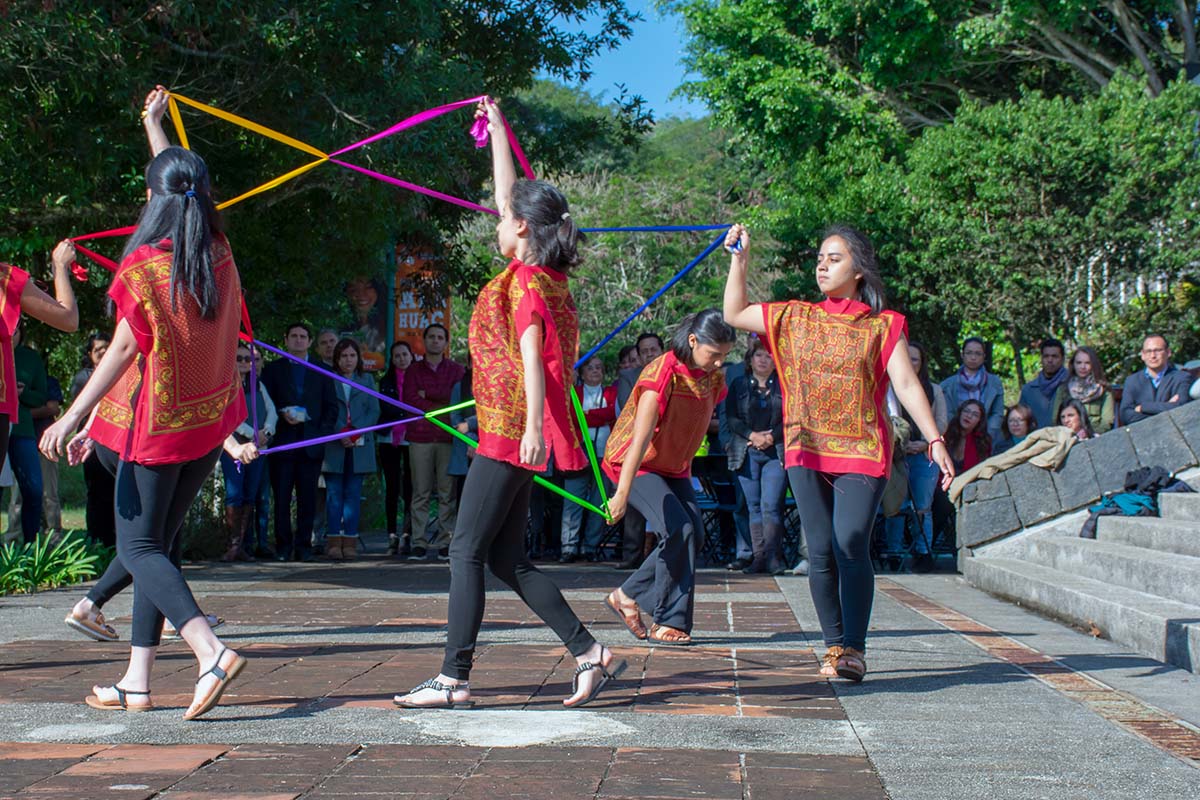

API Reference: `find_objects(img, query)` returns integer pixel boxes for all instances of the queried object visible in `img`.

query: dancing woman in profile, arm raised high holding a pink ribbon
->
[395,100,625,709]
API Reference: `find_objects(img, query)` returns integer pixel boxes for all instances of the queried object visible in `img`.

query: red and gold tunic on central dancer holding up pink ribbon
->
[469,259,588,471]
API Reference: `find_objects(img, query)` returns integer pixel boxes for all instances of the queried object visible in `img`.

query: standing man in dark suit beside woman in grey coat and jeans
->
[262,323,337,561]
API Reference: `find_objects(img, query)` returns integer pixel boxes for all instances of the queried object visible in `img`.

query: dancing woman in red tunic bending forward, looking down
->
[604,308,737,645]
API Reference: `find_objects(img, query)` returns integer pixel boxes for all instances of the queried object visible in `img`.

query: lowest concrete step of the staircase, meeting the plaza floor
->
[964,557,1200,673]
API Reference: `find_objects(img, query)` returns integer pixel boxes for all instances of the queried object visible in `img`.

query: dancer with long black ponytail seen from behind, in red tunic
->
[41,148,257,720]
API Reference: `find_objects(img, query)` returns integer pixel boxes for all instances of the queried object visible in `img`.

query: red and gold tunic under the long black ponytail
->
[108,237,246,464]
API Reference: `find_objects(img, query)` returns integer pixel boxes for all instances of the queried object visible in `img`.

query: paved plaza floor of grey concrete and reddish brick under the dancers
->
[0,542,1200,800]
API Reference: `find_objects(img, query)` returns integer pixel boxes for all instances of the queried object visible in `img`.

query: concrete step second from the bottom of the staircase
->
[1014,536,1200,603]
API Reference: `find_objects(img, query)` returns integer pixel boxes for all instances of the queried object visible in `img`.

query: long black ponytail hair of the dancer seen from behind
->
[121,148,223,319]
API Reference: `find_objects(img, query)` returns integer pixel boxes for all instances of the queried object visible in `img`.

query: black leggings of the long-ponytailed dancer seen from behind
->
[115,447,221,648]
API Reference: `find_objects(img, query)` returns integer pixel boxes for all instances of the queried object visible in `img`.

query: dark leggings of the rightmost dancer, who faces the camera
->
[787,467,887,651]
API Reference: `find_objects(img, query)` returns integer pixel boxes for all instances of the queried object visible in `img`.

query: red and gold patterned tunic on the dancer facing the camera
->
[762,297,907,476]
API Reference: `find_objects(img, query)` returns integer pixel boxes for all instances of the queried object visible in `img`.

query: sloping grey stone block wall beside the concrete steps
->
[958,402,1200,555]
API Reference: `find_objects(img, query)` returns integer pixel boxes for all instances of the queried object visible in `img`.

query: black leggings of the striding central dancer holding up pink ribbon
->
[442,455,595,680]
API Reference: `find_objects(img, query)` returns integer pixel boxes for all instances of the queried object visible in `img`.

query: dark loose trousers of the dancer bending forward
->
[620,473,704,633]
